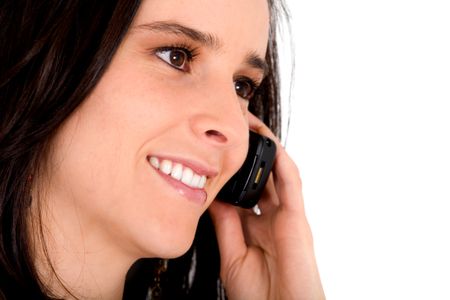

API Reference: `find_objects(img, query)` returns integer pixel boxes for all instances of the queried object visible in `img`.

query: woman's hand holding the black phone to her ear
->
[209,115,325,300]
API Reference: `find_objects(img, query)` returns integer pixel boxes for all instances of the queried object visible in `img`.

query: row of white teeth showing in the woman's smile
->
[149,156,207,189]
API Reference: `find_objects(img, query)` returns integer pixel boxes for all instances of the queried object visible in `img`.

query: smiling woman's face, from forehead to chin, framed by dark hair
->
[46,0,269,257]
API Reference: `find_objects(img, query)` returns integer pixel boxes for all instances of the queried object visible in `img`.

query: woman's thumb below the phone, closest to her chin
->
[209,201,247,270]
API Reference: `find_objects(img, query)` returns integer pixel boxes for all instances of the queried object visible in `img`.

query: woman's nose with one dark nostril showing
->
[190,79,248,147]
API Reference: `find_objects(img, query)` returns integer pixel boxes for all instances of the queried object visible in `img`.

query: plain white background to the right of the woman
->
[283,0,450,300]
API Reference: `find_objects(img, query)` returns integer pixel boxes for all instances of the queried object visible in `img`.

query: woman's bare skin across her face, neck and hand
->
[32,0,323,299]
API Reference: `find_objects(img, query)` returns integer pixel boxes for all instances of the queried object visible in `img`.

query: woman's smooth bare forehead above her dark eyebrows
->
[134,0,269,56]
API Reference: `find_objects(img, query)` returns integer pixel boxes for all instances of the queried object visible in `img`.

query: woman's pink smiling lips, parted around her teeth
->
[147,155,217,205]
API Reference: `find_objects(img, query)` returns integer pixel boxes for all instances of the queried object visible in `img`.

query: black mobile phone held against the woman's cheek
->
[217,131,276,208]
